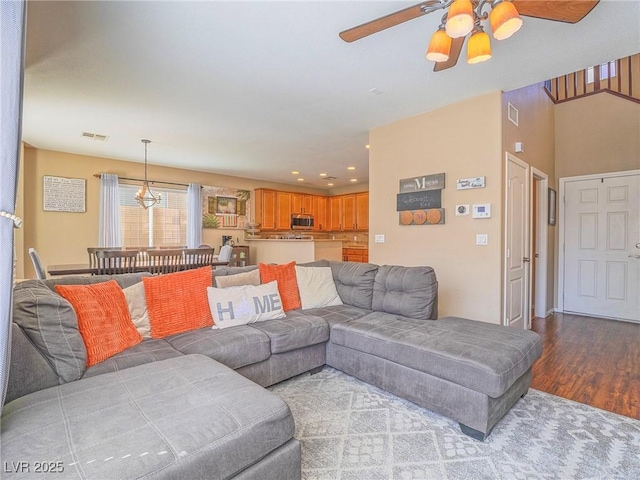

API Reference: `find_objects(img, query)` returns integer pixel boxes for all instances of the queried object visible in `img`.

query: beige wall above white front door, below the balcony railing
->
[555,93,640,178]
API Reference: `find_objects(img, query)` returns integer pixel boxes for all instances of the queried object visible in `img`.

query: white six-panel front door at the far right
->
[563,174,640,321]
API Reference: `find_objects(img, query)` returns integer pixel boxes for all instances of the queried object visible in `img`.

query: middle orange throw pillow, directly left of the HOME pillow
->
[142,267,213,338]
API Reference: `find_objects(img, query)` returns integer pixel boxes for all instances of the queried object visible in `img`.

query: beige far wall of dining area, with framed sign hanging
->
[19,148,326,278]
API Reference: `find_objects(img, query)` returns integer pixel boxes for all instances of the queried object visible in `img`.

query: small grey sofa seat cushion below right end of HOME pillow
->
[250,310,329,353]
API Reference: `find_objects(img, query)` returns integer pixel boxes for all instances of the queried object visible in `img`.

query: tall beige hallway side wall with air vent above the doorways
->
[502,83,558,312]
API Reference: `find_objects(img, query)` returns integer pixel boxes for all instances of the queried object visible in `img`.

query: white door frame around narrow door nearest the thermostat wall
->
[502,152,531,329]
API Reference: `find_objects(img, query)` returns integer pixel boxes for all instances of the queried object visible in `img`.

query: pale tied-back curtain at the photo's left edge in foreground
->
[0,1,26,407]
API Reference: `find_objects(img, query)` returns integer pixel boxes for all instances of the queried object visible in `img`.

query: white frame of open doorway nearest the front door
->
[529,167,553,320]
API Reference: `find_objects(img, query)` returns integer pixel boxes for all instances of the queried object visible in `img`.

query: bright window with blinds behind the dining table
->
[120,183,187,247]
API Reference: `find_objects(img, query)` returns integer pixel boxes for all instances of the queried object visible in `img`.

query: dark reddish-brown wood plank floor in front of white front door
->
[531,314,640,419]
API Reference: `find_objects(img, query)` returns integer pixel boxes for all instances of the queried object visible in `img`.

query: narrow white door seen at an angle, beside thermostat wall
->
[505,154,530,328]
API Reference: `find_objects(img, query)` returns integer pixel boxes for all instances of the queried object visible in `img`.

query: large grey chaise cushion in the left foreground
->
[1,355,294,479]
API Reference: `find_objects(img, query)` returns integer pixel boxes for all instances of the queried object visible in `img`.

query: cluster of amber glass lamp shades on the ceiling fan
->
[426,0,522,63]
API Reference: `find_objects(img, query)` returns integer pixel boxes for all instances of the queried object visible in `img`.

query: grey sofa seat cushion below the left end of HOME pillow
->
[166,320,271,370]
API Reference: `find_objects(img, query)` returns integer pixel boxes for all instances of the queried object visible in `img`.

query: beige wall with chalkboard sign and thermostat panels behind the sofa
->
[369,92,503,323]
